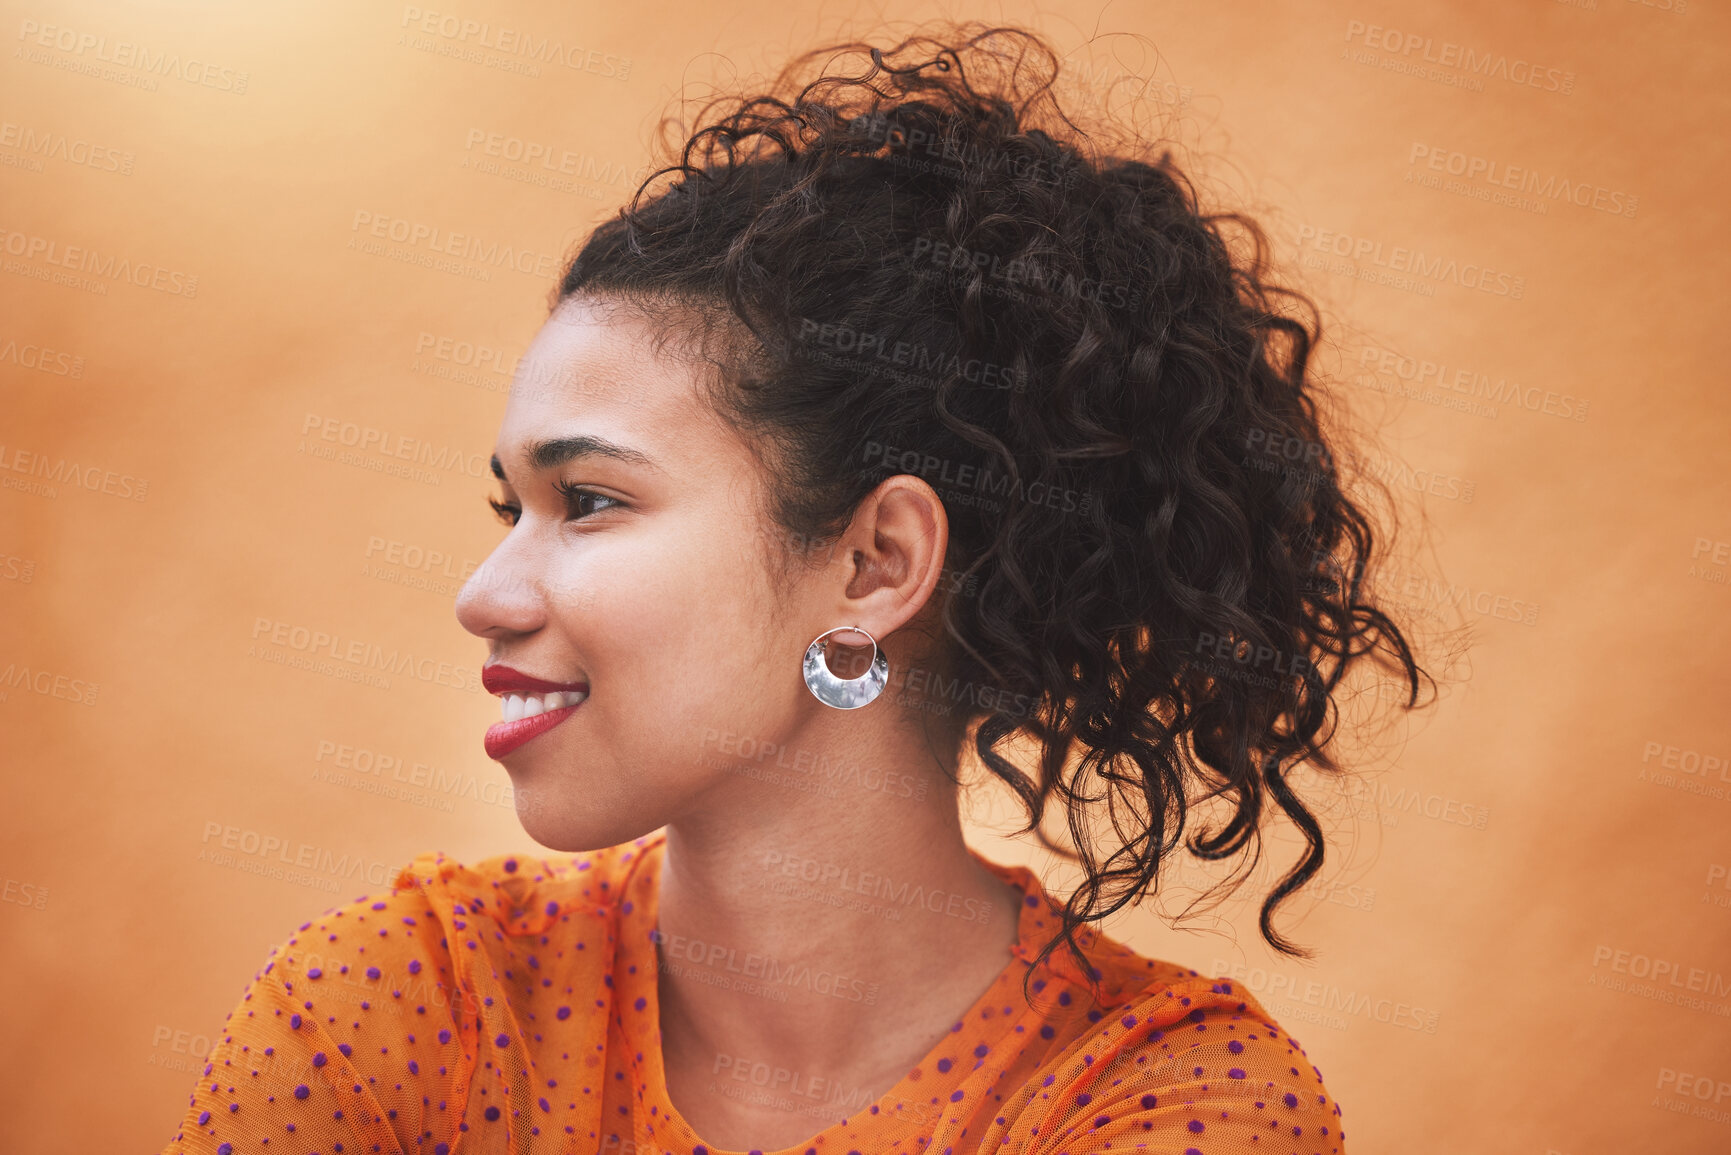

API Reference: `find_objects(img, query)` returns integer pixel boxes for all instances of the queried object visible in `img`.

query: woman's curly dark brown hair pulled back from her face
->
[552,23,1430,1004]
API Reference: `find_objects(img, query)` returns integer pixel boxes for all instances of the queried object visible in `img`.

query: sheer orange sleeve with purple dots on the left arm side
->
[163,890,474,1155]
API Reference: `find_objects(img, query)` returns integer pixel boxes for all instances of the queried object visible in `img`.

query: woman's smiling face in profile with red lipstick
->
[457,300,930,850]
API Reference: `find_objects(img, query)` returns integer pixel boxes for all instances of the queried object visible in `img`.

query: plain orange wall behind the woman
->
[0,0,1731,1155]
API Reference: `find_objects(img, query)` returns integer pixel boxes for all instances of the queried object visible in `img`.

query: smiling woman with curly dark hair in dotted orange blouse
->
[164,26,1421,1155]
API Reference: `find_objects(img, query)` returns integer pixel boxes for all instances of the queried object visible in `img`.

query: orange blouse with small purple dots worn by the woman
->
[163,833,1345,1155]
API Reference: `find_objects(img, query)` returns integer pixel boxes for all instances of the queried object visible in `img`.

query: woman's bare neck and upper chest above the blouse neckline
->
[658,716,1021,1150]
